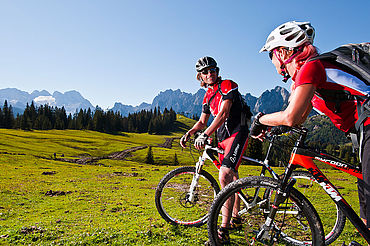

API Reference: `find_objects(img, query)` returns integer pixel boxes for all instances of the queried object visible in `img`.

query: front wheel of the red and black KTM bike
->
[208,176,324,246]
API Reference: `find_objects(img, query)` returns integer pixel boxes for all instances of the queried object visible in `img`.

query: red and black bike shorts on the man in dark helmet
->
[218,127,249,173]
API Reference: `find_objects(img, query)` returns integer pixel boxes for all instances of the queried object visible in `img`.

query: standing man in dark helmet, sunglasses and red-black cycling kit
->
[180,56,251,243]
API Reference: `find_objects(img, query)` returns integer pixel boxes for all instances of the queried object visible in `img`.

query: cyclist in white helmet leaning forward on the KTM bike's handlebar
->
[250,21,370,246]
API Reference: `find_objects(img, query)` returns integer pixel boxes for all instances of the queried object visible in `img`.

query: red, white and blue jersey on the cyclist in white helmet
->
[292,60,370,132]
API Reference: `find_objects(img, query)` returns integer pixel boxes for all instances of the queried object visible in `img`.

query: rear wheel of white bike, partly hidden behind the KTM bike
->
[292,171,346,245]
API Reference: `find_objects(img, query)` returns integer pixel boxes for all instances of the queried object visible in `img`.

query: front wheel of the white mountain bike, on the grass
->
[155,166,220,227]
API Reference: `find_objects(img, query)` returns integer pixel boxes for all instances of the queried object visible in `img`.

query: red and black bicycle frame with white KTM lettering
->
[282,128,370,244]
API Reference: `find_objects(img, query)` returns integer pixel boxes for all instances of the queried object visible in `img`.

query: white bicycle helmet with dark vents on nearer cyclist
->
[260,21,315,53]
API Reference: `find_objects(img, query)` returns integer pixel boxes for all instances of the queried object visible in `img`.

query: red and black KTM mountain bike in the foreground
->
[208,127,370,245]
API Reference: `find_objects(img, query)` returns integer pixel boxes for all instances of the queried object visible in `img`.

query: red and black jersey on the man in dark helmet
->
[202,79,246,141]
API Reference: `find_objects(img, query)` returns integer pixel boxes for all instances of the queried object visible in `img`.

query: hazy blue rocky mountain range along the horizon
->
[0,86,289,117]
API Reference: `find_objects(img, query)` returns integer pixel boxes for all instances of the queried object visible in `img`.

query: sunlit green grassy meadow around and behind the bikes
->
[0,117,363,245]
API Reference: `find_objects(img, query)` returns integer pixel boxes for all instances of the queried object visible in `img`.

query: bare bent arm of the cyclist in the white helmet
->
[259,84,316,126]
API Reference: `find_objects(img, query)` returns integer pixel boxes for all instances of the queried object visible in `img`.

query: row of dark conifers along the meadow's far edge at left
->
[0,100,176,134]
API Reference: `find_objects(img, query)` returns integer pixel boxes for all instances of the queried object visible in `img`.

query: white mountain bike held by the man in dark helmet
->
[155,135,345,244]
